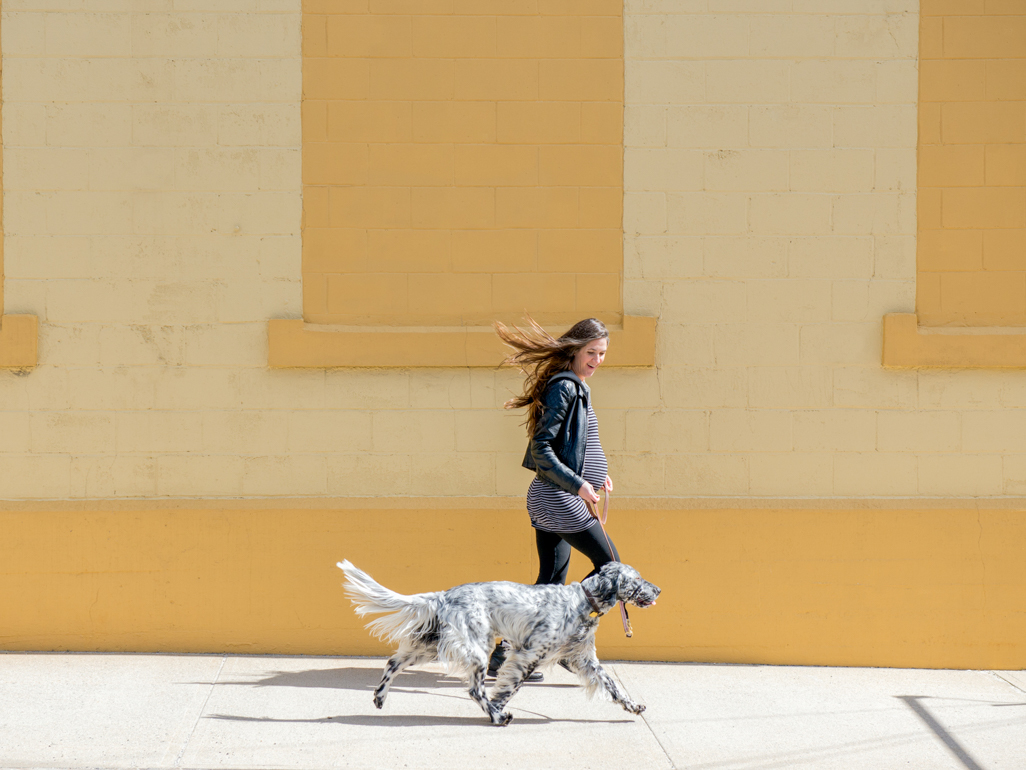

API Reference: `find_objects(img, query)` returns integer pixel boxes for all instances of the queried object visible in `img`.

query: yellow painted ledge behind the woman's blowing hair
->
[268,315,656,369]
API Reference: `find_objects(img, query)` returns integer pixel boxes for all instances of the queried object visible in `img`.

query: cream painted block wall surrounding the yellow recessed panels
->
[0,0,1026,499]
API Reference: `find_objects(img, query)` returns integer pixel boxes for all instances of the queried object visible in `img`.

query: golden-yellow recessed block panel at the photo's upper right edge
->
[916,0,1026,326]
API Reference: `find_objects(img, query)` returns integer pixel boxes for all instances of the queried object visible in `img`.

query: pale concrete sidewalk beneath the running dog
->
[0,653,1026,770]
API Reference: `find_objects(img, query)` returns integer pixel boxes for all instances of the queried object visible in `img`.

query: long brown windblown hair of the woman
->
[495,315,609,435]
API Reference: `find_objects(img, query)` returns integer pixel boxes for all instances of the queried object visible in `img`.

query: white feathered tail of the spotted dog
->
[336,560,436,644]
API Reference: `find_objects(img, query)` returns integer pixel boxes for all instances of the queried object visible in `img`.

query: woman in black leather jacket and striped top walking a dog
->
[488,317,620,676]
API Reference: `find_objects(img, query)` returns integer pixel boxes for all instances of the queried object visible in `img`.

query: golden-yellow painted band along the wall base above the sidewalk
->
[0,501,1026,668]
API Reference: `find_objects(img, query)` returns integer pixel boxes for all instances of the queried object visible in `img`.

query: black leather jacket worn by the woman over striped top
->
[523,371,591,495]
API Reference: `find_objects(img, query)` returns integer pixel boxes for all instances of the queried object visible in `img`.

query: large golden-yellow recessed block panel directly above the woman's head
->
[303,0,623,325]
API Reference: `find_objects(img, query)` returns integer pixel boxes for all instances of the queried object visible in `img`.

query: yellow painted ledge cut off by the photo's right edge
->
[883,313,1026,369]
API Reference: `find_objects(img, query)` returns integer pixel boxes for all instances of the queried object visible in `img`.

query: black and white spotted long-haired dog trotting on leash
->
[338,562,660,726]
